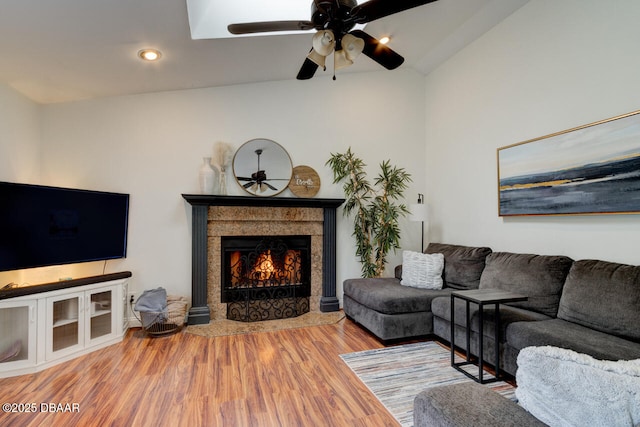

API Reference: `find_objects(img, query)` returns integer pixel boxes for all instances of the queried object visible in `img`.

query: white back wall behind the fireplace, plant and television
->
[6,70,425,297]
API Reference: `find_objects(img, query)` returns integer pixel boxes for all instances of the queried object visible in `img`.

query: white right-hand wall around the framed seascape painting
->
[425,0,640,264]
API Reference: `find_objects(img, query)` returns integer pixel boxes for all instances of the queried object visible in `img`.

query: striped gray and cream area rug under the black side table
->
[340,342,515,427]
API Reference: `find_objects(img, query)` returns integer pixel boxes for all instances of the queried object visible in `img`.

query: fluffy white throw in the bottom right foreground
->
[516,346,640,427]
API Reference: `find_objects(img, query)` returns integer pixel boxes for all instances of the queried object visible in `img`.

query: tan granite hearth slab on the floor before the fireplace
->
[186,310,344,337]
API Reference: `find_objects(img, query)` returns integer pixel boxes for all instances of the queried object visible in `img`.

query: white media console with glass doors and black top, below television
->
[0,272,131,378]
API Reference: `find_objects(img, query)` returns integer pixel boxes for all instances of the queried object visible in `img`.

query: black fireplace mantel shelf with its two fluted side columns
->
[182,194,344,325]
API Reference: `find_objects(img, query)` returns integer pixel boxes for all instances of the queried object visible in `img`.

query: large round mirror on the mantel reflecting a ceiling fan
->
[233,138,293,197]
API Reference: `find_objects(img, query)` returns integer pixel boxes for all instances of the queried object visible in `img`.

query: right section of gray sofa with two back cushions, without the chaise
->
[431,252,640,375]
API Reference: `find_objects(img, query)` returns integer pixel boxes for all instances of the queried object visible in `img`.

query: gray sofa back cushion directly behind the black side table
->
[479,252,573,317]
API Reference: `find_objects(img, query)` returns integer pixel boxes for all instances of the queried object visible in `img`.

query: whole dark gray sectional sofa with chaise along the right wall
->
[343,243,640,375]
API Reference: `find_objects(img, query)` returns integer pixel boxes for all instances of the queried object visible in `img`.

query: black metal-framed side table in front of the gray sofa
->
[451,289,528,384]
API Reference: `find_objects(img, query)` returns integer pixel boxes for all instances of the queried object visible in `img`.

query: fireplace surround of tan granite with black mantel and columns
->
[182,194,344,325]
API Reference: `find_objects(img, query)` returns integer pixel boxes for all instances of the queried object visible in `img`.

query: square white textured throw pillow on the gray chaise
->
[400,251,444,289]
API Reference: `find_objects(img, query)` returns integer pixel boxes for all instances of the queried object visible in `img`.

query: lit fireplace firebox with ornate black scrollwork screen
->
[220,235,311,322]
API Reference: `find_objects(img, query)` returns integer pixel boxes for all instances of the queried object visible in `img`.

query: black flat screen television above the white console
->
[0,182,129,271]
